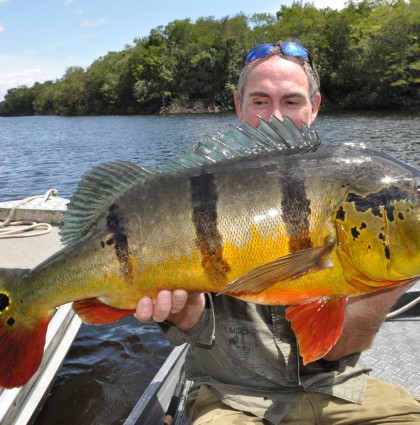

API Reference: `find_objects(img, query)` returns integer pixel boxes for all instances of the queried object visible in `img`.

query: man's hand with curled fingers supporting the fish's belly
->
[136,289,206,331]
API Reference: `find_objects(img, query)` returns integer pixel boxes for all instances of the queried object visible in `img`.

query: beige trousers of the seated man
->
[186,377,420,425]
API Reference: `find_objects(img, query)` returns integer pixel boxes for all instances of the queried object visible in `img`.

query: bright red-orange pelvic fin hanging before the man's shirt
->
[286,295,346,365]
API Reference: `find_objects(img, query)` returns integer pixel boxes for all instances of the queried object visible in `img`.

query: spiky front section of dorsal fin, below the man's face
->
[157,115,321,173]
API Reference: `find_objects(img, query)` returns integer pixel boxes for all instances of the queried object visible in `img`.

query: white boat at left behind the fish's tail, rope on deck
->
[0,190,81,425]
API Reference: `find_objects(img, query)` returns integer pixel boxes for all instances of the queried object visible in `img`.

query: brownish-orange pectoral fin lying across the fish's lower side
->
[218,239,335,296]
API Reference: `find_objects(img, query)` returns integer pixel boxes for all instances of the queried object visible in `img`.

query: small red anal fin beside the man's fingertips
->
[73,298,135,325]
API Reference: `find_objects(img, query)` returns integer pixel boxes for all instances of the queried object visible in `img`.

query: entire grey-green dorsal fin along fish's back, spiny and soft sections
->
[60,116,321,244]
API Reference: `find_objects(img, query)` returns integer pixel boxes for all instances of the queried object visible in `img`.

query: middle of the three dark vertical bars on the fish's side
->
[190,174,230,283]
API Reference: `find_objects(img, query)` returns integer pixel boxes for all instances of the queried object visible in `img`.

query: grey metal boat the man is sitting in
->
[124,281,420,425]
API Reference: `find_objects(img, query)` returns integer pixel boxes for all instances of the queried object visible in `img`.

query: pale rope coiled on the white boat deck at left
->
[0,189,58,239]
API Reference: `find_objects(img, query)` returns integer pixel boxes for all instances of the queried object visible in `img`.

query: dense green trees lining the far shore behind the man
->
[0,0,420,115]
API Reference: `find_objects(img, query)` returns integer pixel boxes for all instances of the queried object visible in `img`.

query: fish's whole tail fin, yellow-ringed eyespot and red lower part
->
[0,270,52,388]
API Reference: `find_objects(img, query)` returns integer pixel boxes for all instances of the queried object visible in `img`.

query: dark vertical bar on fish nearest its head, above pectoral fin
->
[281,165,313,252]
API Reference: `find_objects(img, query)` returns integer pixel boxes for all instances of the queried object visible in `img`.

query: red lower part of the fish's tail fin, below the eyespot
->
[0,317,49,388]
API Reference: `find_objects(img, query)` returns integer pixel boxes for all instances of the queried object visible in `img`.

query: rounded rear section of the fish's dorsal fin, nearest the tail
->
[60,161,159,243]
